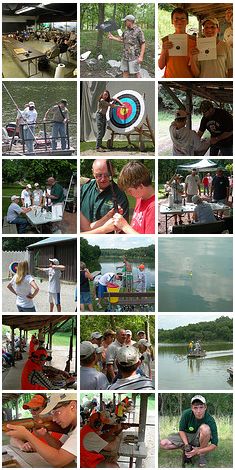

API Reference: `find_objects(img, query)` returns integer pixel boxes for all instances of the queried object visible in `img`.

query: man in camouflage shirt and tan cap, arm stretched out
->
[108,15,145,78]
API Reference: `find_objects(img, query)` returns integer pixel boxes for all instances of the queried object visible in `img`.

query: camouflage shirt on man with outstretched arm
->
[122,26,145,60]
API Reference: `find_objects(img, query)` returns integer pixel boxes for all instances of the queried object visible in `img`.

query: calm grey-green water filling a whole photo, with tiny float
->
[158,237,233,312]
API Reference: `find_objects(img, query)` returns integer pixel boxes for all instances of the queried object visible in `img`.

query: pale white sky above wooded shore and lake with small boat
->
[158,313,233,330]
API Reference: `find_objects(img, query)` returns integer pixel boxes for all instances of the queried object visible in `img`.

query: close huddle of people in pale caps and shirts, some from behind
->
[80,328,154,391]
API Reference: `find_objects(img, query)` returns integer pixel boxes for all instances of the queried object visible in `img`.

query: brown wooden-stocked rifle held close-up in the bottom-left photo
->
[2,417,70,434]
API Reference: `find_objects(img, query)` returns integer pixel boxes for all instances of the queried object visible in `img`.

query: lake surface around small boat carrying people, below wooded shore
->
[158,342,233,391]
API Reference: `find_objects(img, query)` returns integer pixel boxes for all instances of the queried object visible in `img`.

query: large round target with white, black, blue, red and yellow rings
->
[106,90,145,134]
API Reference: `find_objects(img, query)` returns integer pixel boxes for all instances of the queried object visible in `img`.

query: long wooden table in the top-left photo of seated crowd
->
[3,36,45,77]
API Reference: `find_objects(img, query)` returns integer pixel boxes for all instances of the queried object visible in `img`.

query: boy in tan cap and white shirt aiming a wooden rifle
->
[6,392,77,468]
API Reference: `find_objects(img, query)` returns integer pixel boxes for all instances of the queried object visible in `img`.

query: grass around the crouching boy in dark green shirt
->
[158,416,233,468]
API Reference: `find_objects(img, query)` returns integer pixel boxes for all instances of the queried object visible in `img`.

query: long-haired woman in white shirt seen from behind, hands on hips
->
[7,261,39,312]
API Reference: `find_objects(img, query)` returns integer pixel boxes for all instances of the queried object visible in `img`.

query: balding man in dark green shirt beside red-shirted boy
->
[80,159,129,223]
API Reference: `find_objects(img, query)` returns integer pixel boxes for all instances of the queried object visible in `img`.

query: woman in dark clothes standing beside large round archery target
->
[96,90,125,152]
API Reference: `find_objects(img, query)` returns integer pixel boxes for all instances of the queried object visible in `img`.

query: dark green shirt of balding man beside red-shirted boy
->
[81,179,129,222]
